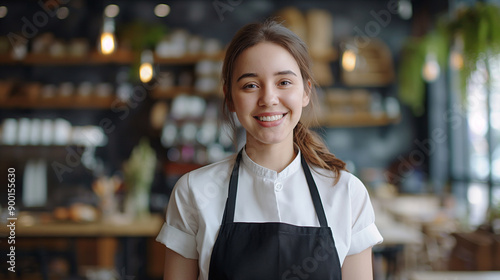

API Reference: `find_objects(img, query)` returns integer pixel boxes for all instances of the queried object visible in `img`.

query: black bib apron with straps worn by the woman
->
[208,151,342,280]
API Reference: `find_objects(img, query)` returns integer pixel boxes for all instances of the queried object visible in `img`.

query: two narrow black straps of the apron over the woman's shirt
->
[222,148,328,227]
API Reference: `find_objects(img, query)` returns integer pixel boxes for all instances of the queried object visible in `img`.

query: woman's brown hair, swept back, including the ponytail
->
[222,20,346,183]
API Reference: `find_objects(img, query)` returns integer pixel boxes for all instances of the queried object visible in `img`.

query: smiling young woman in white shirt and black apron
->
[157,21,382,280]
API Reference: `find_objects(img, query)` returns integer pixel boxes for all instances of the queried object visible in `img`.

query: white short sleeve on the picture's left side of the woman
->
[156,173,198,259]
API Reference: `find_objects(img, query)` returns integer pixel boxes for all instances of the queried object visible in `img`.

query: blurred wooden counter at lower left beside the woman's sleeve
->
[0,212,165,279]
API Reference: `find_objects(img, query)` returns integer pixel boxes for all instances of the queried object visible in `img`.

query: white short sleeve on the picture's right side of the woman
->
[347,176,383,255]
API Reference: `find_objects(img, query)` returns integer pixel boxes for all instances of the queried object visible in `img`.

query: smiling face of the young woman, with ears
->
[228,42,310,149]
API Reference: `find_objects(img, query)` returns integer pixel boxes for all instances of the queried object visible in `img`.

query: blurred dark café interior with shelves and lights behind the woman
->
[0,0,500,280]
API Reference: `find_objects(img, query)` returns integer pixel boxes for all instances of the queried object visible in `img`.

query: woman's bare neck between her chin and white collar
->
[245,142,297,173]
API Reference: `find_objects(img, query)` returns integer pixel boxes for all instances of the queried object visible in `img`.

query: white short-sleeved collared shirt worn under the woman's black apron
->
[156,149,382,279]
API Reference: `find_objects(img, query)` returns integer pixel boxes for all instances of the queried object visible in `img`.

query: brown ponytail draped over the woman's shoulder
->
[293,121,347,184]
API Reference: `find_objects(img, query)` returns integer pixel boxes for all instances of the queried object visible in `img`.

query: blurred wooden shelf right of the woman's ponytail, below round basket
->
[318,113,401,127]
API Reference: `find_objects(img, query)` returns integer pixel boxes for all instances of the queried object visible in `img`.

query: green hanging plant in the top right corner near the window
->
[399,2,500,115]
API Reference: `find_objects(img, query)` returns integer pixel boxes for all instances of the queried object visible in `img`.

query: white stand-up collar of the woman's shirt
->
[241,148,301,180]
